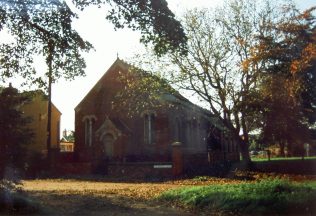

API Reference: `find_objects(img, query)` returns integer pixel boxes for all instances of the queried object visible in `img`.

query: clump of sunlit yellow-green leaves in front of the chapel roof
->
[112,65,182,117]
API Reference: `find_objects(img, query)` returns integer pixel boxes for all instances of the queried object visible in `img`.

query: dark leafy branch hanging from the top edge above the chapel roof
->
[73,0,187,56]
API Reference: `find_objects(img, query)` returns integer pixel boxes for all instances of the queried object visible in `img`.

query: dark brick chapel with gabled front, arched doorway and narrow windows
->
[74,59,238,176]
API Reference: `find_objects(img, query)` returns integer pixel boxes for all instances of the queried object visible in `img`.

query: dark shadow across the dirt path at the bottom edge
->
[29,191,188,216]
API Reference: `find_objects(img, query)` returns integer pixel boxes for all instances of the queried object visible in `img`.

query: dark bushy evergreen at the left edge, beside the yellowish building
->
[0,86,32,179]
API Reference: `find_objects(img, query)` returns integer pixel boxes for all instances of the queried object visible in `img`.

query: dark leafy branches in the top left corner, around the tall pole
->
[0,0,92,85]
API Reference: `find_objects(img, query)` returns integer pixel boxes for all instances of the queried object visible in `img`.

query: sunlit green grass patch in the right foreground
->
[159,179,316,215]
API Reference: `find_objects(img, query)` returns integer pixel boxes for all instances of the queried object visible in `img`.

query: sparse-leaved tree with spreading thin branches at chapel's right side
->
[123,1,282,161]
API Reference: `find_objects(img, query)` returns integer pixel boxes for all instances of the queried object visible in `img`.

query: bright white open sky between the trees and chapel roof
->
[1,0,316,130]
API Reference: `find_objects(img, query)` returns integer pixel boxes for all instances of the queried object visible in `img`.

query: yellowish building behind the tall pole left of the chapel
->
[21,90,61,155]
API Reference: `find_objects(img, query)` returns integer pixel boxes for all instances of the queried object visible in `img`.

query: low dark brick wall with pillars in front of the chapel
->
[55,150,239,179]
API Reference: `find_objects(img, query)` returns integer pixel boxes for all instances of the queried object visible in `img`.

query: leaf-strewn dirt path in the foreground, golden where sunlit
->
[23,180,193,216]
